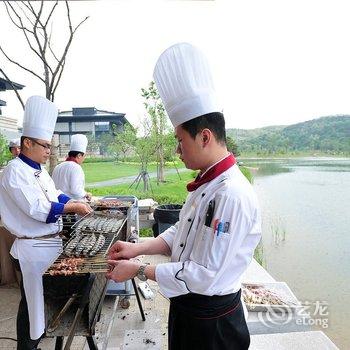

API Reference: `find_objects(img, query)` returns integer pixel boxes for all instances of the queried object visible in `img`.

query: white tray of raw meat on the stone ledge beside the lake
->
[242,282,301,312]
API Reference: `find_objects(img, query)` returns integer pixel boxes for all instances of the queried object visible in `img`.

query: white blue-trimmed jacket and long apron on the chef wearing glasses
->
[0,154,70,339]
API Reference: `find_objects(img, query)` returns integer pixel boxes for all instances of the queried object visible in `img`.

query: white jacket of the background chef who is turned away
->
[52,161,86,199]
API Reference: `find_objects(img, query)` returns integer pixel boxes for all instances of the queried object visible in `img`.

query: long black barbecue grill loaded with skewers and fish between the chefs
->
[43,196,145,350]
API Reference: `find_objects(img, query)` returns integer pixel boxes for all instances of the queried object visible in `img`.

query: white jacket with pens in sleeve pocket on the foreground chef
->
[156,165,261,298]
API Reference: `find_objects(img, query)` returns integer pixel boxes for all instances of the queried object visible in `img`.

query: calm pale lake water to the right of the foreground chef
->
[241,158,350,349]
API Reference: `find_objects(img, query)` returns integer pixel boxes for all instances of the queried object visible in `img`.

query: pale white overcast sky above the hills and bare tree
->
[0,0,350,129]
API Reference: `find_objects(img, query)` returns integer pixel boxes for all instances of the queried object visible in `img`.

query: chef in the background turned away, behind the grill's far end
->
[52,134,91,200]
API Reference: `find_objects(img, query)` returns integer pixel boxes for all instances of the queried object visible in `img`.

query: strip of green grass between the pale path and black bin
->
[89,170,193,204]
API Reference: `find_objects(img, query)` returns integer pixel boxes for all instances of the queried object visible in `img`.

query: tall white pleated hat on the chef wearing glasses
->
[23,96,58,141]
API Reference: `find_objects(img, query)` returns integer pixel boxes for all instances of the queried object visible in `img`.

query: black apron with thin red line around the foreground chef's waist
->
[168,291,250,350]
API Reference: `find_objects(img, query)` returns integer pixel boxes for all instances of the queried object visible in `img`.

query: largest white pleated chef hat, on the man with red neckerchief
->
[153,43,222,127]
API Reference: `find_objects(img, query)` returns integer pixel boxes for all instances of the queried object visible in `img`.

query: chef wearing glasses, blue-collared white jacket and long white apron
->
[0,96,91,350]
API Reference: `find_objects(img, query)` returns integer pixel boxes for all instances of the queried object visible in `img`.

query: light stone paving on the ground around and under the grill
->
[0,252,169,350]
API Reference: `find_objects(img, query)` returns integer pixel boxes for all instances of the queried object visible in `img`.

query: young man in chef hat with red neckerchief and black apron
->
[107,43,261,350]
